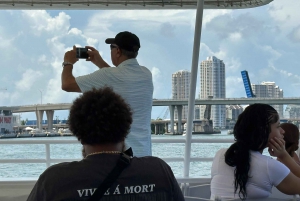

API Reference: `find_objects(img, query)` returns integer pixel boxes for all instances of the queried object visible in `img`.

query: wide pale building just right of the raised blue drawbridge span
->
[251,82,283,118]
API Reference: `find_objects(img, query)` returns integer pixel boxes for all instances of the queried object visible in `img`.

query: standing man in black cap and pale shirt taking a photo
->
[61,31,153,157]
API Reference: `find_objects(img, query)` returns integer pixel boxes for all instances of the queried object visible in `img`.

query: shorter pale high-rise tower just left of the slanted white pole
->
[172,70,191,119]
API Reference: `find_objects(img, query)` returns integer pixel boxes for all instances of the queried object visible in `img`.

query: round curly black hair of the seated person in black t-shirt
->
[69,87,132,145]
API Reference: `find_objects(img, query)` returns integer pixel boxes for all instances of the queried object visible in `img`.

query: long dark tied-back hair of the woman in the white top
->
[225,103,279,200]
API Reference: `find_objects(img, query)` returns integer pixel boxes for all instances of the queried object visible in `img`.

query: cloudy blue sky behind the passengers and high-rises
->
[0,0,300,119]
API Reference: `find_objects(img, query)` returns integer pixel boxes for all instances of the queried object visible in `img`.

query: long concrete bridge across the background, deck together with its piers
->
[0,97,300,133]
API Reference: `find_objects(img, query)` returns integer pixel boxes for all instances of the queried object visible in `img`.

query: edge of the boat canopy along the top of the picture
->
[0,0,272,10]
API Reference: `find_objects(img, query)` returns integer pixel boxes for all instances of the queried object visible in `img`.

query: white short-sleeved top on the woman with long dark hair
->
[210,149,290,199]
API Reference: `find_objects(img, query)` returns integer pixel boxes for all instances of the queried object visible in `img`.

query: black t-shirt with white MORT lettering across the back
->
[27,154,184,201]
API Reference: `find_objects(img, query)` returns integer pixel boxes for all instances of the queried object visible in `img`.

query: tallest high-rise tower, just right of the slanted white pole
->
[200,56,226,128]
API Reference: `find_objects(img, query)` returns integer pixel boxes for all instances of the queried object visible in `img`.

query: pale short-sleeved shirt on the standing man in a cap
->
[76,59,153,157]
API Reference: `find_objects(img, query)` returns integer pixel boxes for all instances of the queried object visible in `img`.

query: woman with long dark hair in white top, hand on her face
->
[211,104,300,200]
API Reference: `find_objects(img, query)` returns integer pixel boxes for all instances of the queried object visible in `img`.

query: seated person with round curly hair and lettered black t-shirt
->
[27,87,184,201]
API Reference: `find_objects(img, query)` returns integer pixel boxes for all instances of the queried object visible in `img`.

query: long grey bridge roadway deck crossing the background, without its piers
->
[0,97,300,113]
